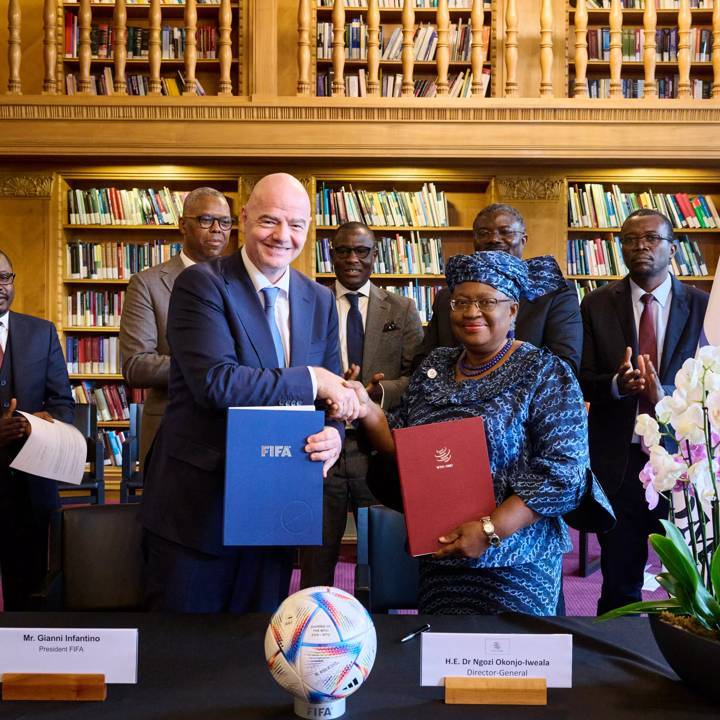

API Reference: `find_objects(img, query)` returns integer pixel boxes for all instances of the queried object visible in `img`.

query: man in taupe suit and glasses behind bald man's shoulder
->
[120,187,232,464]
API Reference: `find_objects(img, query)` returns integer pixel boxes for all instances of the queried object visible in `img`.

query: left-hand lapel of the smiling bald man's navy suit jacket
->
[220,251,277,368]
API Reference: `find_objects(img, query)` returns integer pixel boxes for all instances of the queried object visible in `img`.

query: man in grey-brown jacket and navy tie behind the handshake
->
[300,222,423,587]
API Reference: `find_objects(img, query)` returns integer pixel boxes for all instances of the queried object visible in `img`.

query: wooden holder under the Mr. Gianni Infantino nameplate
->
[2,673,107,700]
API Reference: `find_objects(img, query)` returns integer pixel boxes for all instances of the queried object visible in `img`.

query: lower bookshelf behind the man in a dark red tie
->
[565,171,720,297]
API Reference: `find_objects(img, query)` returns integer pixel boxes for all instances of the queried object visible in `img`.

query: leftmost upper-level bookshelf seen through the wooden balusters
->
[57,0,245,96]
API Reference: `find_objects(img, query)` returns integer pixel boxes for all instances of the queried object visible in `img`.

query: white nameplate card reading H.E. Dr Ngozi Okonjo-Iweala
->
[420,632,572,687]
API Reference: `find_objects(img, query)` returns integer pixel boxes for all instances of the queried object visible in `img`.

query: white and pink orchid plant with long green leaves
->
[603,346,720,633]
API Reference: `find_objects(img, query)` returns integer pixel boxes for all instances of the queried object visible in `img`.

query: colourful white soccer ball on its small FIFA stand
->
[265,587,377,718]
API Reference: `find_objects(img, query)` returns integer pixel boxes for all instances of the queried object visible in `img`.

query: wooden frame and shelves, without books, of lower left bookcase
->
[53,167,241,489]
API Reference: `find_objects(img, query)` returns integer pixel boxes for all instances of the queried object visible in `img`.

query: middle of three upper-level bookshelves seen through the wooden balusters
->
[311,0,496,97]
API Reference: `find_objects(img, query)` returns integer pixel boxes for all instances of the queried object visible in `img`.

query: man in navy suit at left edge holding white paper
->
[0,251,75,610]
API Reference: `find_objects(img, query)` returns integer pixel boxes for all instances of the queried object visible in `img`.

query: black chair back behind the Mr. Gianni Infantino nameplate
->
[37,505,143,611]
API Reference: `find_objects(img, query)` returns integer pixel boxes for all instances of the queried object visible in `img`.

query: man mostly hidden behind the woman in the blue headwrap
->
[413,203,582,374]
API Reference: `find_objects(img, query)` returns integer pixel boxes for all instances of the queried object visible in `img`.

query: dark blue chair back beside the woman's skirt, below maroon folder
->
[355,505,419,612]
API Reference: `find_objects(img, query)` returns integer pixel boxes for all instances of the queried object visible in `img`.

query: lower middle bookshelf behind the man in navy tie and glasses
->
[308,169,495,322]
